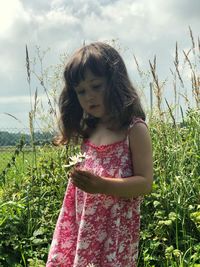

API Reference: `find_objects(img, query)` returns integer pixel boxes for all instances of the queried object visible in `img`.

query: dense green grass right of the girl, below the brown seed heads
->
[139,110,200,266]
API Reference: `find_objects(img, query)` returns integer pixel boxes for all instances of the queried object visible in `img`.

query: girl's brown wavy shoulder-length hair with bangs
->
[59,42,145,144]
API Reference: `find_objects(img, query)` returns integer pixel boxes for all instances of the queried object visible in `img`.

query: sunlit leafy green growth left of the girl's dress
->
[0,144,67,266]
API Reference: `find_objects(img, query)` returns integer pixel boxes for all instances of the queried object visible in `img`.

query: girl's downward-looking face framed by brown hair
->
[75,70,107,119]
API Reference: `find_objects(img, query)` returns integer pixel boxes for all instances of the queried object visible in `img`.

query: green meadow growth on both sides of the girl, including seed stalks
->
[0,31,200,267]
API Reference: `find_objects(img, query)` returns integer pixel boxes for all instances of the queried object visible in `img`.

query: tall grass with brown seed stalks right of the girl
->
[137,28,200,267]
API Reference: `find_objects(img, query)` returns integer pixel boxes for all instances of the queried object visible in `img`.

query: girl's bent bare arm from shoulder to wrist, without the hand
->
[101,123,153,198]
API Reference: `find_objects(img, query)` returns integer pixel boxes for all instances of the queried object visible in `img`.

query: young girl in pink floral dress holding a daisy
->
[46,42,153,267]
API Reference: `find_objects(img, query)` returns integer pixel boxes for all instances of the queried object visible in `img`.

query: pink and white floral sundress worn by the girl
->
[46,118,147,267]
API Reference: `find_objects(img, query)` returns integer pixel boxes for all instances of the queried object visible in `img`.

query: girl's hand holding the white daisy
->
[71,169,105,194]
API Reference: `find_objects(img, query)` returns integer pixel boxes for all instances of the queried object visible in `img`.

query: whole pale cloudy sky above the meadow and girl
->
[0,0,200,131]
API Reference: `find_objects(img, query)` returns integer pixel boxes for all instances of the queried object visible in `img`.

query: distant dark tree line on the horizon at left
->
[0,131,54,146]
